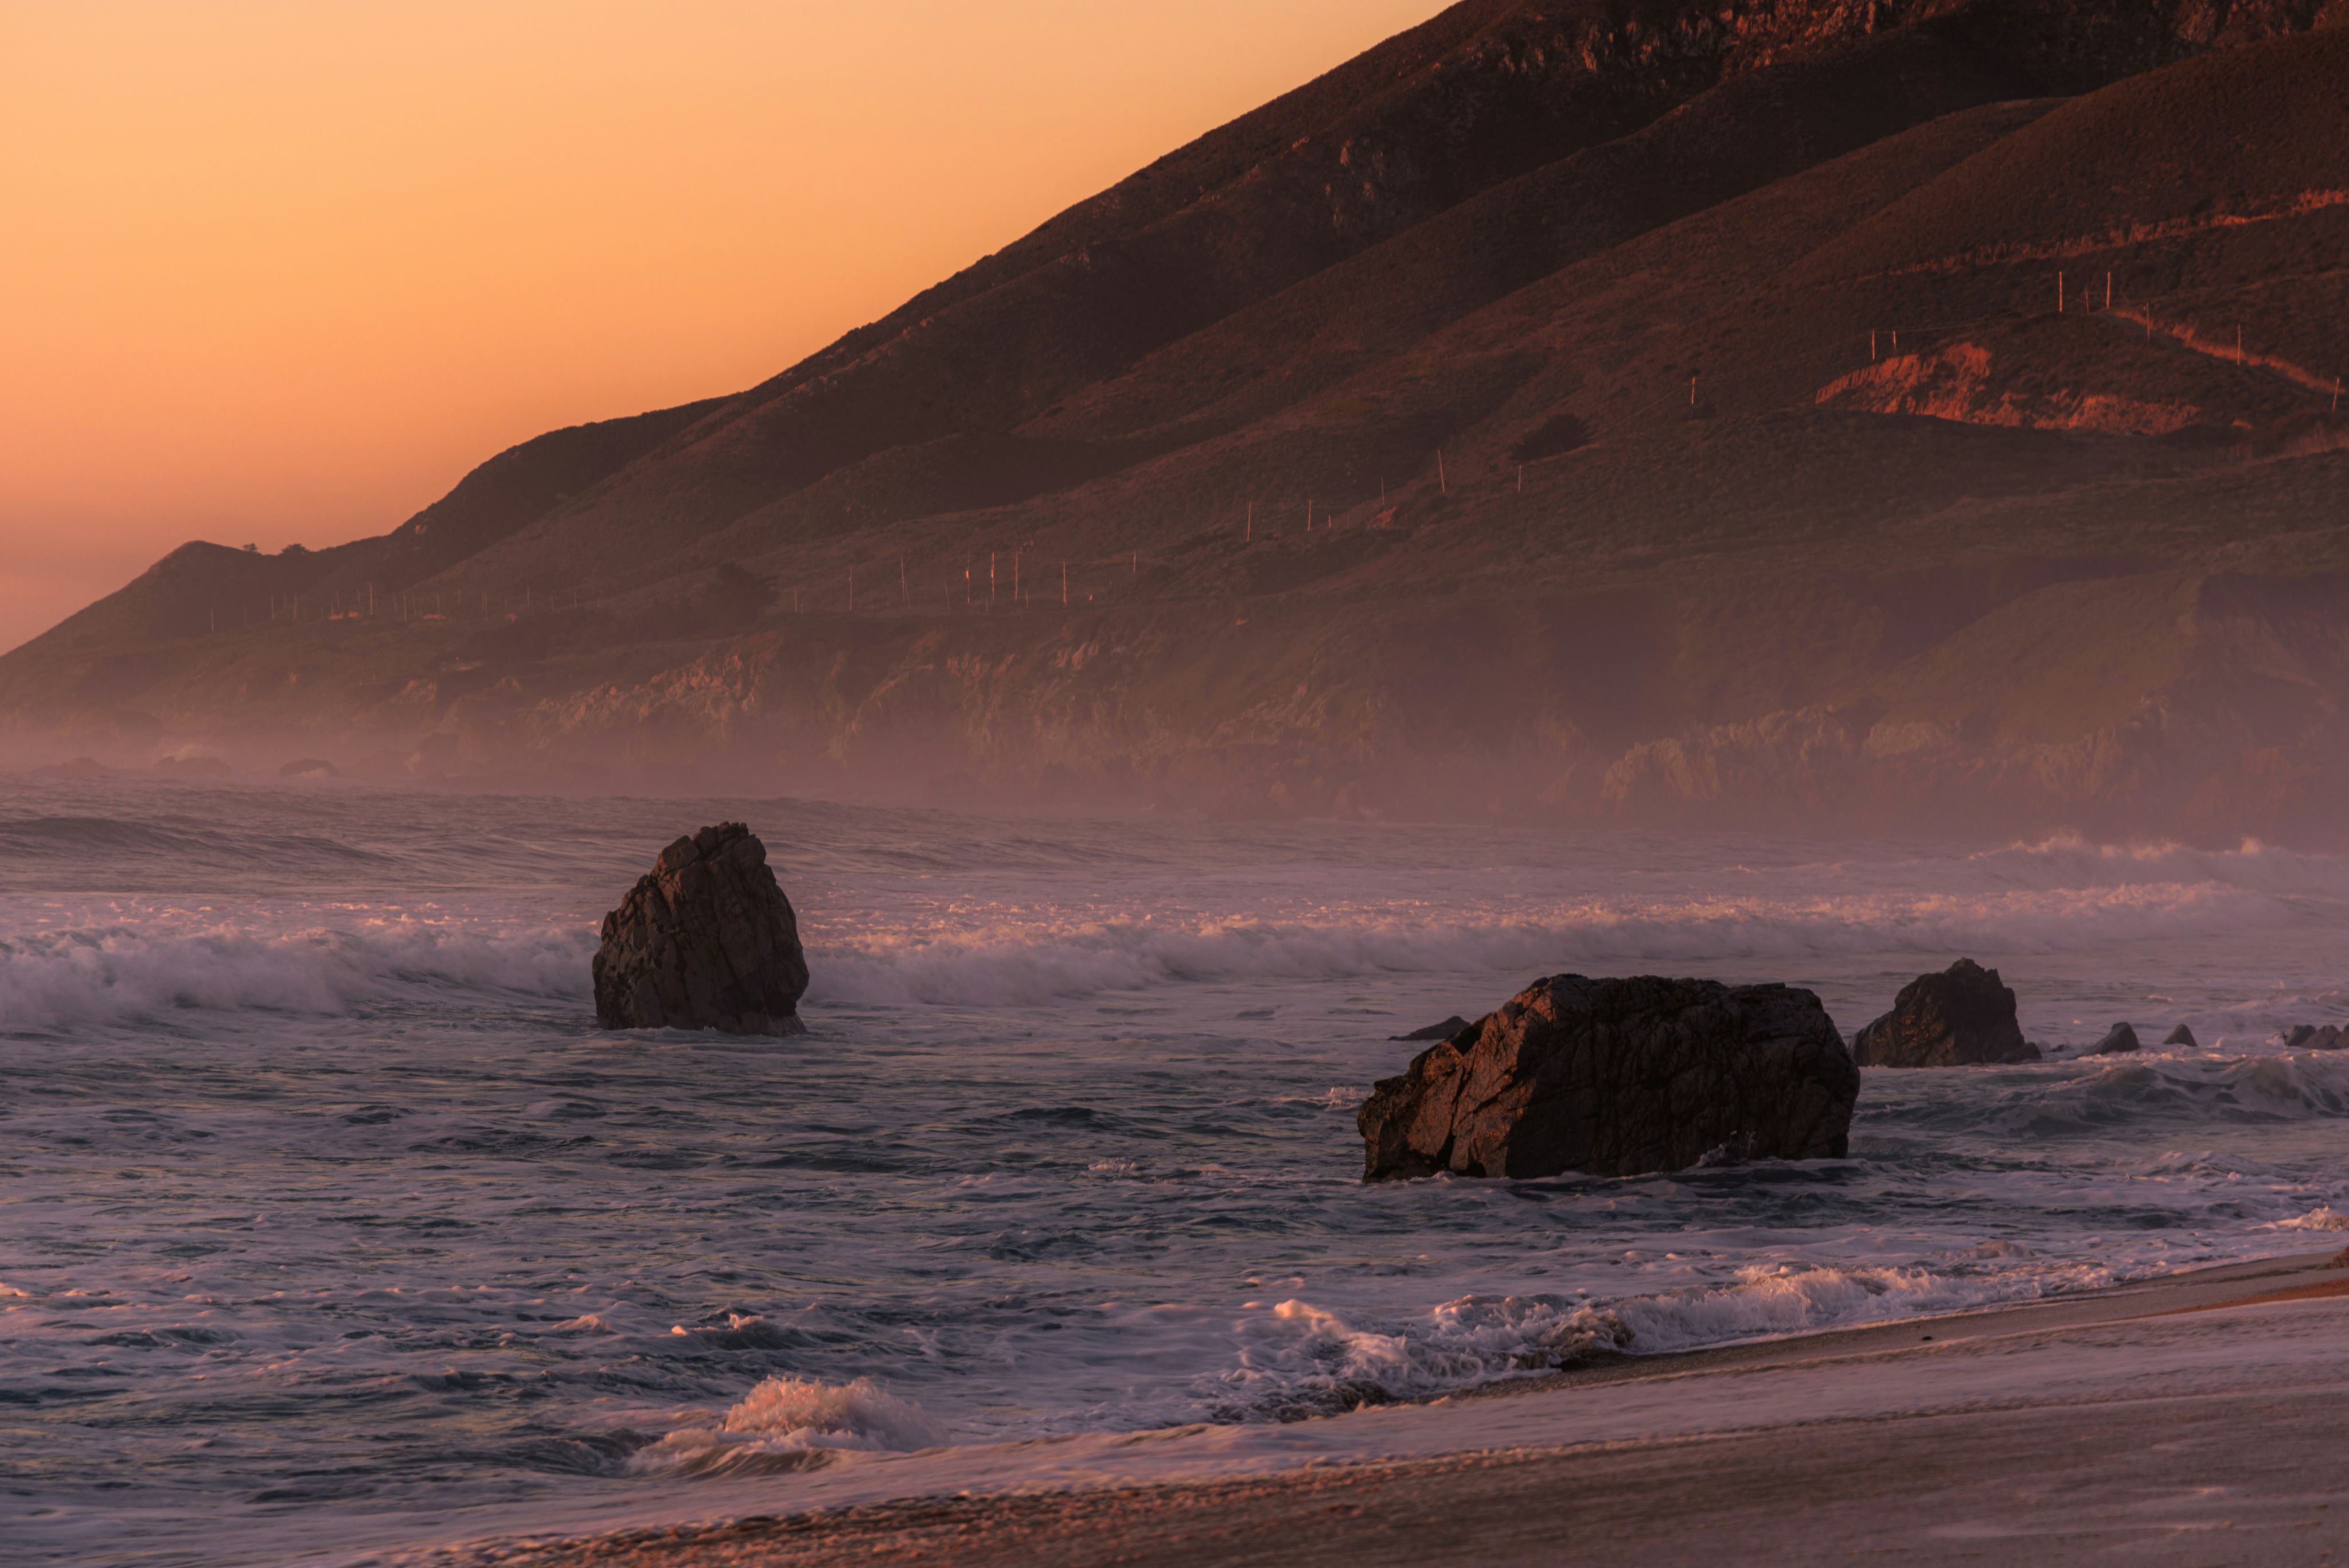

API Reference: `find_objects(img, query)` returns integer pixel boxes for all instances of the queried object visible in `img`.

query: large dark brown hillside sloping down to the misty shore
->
[0,0,2349,839]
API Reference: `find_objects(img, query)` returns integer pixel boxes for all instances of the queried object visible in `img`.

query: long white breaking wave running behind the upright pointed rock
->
[0,881,2295,1032]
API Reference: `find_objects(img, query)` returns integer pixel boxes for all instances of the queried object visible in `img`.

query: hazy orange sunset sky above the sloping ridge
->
[0,0,1442,649]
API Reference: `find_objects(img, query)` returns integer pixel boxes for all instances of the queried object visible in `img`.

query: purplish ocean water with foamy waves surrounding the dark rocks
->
[0,781,2349,1563]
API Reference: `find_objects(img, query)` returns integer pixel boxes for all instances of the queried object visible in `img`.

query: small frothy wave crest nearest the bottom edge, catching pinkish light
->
[630,1378,949,1476]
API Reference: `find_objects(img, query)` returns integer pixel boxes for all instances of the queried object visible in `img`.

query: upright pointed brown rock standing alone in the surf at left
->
[594,823,808,1035]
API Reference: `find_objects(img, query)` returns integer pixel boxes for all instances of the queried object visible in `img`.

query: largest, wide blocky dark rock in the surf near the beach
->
[1357,976,1860,1183]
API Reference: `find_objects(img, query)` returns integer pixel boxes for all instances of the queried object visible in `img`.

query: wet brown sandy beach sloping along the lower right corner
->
[369,1253,2349,1568]
